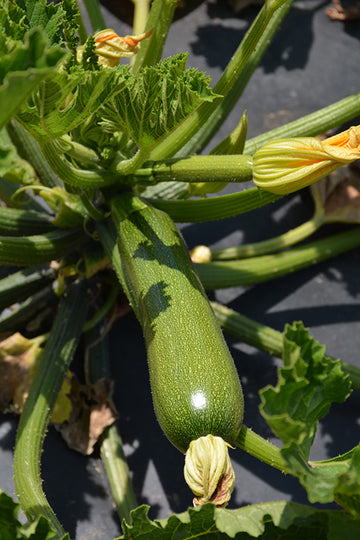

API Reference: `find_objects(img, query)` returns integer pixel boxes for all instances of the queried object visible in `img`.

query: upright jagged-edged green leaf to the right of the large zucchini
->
[260,322,351,459]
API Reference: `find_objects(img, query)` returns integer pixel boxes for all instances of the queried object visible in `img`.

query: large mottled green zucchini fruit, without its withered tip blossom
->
[113,199,244,452]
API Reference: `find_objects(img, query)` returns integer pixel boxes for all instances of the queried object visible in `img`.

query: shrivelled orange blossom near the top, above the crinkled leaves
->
[78,28,152,67]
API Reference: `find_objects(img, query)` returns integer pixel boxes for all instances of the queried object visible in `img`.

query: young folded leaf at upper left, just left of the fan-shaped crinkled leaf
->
[17,66,128,142]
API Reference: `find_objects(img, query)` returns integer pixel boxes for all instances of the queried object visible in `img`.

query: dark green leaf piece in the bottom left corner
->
[0,490,69,540]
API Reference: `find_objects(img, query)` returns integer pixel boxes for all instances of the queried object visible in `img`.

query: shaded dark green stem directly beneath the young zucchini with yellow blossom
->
[149,188,280,223]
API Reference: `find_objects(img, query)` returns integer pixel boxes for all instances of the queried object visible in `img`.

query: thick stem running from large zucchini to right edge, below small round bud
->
[195,228,360,290]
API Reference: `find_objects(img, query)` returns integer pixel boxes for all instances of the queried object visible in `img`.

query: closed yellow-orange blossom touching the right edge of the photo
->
[253,125,360,195]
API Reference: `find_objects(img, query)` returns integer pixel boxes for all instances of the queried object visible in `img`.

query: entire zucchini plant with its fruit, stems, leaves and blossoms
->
[0,0,360,540]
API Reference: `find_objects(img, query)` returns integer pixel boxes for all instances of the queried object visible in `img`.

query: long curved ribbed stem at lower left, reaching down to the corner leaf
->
[14,284,89,538]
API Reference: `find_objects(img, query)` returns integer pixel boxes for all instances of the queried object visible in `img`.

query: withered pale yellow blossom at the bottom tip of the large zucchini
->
[184,435,235,506]
